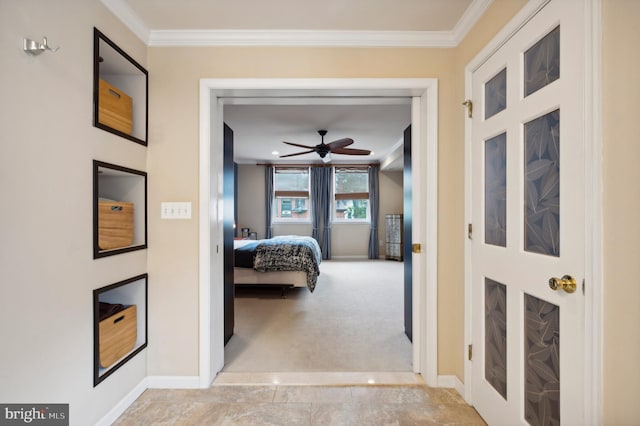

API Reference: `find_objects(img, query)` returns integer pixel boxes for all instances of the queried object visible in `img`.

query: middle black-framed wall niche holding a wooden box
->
[93,160,147,259]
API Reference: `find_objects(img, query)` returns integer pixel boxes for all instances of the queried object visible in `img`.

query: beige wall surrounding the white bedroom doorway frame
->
[148,0,523,379]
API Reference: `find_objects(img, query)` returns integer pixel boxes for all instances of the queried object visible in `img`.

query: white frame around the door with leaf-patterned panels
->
[464,0,603,425]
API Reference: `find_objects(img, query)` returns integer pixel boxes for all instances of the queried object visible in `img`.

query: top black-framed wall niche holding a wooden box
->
[93,27,149,146]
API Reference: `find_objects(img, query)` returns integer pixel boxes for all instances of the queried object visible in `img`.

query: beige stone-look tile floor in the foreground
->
[115,383,485,426]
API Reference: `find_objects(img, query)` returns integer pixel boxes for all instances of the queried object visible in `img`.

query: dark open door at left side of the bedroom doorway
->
[222,124,235,345]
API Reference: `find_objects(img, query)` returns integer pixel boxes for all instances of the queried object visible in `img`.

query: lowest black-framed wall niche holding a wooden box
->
[93,274,149,387]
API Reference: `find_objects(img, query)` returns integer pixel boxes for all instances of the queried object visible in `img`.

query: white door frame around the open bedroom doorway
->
[198,78,438,388]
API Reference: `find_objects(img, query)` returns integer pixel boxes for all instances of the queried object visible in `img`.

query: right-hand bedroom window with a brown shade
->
[333,167,370,222]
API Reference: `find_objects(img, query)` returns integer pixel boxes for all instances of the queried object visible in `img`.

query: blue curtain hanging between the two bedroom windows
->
[311,167,332,259]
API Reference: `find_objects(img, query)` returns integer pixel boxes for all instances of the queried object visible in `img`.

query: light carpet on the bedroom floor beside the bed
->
[222,260,412,372]
